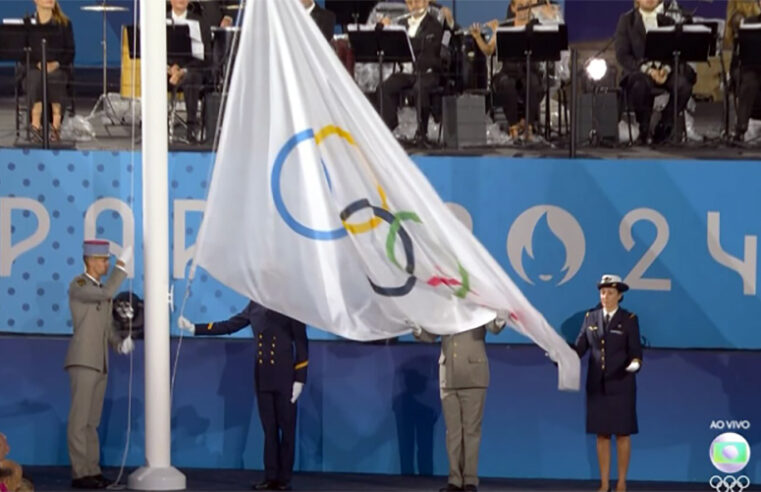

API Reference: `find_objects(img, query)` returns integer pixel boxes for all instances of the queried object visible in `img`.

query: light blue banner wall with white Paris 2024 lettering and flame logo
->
[0,150,761,349]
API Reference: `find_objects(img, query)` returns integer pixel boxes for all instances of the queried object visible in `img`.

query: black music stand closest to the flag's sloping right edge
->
[346,24,412,125]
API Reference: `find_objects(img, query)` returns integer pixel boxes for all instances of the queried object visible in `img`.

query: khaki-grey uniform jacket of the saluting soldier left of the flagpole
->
[64,268,127,372]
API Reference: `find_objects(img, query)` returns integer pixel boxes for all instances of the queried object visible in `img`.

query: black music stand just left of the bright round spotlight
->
[496,23,568,142]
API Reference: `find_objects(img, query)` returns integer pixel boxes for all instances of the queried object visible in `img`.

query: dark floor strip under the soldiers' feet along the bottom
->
[24,467,732,492]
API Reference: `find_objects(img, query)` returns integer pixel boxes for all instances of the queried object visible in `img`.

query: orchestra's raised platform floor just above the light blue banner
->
[0,98,761,160]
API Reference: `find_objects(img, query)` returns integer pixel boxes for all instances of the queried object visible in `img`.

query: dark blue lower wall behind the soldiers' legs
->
[0,337,761,482]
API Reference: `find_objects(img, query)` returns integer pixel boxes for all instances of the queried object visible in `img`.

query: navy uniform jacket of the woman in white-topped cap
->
[575,306,642,394]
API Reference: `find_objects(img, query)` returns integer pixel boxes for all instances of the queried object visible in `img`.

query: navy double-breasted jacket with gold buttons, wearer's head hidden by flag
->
[195,302,309,394]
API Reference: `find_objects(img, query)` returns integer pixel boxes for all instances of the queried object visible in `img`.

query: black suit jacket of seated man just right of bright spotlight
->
[615,9,695,82]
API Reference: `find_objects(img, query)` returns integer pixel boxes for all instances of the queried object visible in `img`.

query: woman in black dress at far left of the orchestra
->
[27,0,74,141]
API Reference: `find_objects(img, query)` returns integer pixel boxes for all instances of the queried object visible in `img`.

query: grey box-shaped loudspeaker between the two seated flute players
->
[441,94,486,148]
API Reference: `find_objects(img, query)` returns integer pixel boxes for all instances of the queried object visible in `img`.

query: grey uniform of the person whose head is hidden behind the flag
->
[417,321,504,487]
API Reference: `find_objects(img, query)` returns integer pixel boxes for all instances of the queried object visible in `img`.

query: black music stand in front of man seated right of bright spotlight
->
[645,24,711,142]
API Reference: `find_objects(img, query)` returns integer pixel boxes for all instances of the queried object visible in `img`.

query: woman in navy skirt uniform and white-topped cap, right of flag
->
[575,274,642,491]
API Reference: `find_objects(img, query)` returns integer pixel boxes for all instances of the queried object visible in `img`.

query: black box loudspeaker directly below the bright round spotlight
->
[576,92,616,143]
